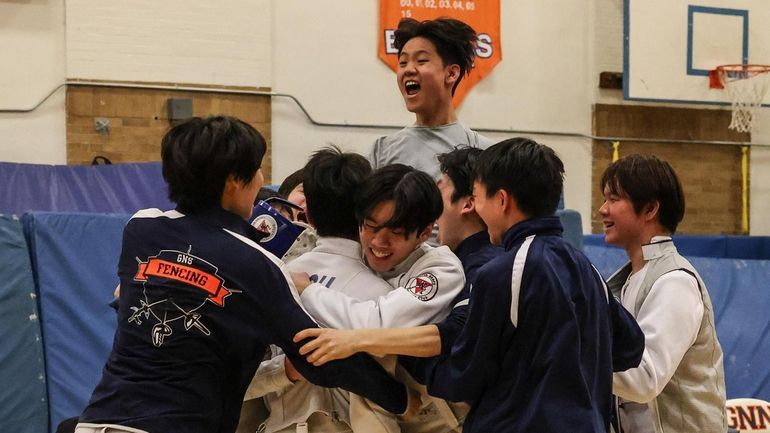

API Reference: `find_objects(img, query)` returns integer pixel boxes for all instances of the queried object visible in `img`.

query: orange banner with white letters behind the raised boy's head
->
[378,0,502,107]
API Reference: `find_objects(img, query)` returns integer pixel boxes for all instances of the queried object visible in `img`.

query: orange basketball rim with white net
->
[709,65,770,132]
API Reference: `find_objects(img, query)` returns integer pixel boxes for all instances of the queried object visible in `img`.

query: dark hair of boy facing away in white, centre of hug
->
[302,146,372,240]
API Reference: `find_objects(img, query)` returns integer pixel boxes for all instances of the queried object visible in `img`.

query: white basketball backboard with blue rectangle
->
[623,0,770,106]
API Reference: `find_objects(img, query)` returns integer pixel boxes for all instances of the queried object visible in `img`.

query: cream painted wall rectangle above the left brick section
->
[67,0,273,87]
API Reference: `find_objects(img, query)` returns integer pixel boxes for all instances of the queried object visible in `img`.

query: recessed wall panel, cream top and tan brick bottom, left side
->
[66,0,273,178]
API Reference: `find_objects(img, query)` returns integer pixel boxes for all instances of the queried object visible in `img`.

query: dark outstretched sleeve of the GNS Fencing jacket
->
[261,267,407,414]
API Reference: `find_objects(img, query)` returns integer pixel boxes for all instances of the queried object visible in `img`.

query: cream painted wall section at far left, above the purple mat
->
[0,0,66,164]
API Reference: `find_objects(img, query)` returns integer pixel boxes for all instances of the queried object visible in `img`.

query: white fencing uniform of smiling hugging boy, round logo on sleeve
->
[301,244,468,433]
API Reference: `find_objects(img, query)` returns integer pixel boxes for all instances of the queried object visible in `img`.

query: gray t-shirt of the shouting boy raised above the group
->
[368,122,494,180]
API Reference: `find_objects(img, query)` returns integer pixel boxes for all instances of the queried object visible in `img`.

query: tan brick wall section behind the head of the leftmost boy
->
[67,85,272,183]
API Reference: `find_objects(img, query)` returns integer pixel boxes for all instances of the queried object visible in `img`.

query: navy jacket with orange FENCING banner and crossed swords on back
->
[80,208,406,433]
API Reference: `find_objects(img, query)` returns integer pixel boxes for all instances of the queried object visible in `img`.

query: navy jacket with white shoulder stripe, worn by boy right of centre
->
[428,217,638,433]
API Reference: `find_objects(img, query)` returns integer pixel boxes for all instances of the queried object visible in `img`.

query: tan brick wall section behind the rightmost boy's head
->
[591,104,750,234]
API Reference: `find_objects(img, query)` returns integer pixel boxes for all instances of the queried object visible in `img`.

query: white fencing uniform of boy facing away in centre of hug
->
[247,237,393,433]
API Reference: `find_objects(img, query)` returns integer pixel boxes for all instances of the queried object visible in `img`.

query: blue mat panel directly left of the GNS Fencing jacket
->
[24,213,129,431]
